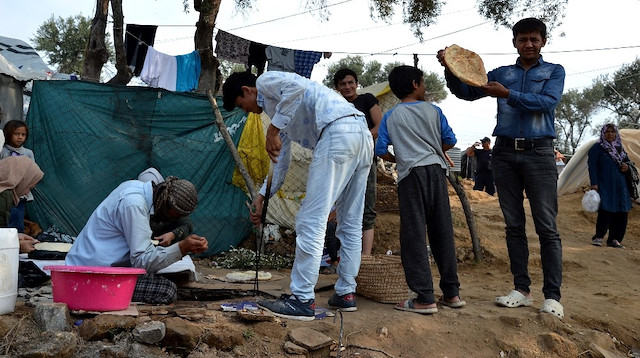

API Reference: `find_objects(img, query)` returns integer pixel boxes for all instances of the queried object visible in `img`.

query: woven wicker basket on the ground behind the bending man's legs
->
[356,255,409,303]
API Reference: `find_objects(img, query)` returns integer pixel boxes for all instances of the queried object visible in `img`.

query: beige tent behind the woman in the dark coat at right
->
[558,129,640,196]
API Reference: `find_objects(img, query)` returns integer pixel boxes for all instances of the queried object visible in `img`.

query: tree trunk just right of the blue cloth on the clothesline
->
[193,0,222,94]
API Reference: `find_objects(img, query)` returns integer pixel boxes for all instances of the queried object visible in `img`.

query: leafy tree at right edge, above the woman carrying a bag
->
[601,59,640,128]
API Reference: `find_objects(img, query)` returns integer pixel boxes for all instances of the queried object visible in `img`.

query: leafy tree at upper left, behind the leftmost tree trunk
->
[31,15,111,75]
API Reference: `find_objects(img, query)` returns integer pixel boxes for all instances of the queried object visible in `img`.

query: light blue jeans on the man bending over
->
[289,116,373,300]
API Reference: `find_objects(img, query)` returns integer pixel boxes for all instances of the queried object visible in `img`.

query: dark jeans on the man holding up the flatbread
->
[491,146,562,301]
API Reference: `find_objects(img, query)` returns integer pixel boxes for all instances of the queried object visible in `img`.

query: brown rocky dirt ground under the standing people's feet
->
[0,176,640,358]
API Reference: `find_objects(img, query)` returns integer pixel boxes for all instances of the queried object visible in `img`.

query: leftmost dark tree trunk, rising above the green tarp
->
[82,0,109,82]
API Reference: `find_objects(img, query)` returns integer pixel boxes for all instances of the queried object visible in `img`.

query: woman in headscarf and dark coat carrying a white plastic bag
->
[588,124,631,249]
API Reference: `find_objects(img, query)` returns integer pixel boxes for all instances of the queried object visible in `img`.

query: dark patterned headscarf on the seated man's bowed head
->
[153,176,198,216]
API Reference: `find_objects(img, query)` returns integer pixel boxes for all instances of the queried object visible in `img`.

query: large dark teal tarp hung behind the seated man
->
[26,81,251,255]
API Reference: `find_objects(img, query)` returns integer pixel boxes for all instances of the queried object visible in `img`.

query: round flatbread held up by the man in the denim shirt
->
[444,45,489,87]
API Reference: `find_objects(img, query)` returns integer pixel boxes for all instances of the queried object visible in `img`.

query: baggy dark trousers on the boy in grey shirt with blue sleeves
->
[398,164,460,304]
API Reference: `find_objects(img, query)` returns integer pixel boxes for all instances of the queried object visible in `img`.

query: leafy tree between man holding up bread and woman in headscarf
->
[555,81,604,154]
